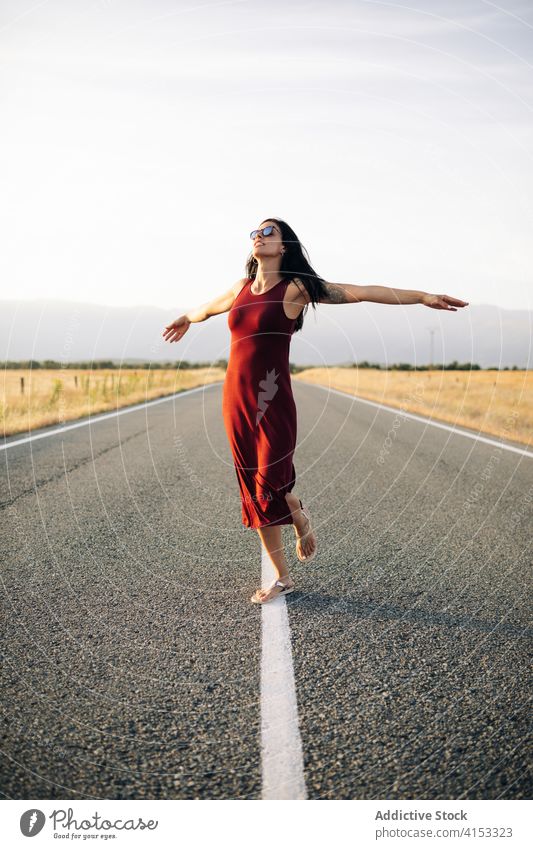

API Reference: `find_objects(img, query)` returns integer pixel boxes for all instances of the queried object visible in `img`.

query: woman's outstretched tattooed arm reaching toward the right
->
[320,283,468,312]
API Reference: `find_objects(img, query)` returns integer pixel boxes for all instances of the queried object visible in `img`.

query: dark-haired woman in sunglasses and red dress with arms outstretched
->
[163,218,467,604]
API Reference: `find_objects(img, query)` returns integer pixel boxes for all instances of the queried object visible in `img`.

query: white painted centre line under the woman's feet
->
[261,545,307,799]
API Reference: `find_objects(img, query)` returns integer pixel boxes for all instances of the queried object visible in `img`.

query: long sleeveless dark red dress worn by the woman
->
[222,278,296,529]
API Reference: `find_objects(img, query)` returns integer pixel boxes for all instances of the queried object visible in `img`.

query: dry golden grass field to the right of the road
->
[292,368,533,445]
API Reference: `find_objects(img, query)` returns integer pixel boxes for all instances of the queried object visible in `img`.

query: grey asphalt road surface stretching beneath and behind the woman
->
[0,381,533,799]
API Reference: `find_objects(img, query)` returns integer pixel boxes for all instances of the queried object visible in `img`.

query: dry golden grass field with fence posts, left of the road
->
[0,368,225,436]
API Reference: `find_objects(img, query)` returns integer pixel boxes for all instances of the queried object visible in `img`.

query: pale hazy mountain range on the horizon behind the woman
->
[0,299,533,368]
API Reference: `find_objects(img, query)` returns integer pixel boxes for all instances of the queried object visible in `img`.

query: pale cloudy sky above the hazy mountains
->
[0,0,533,317]
